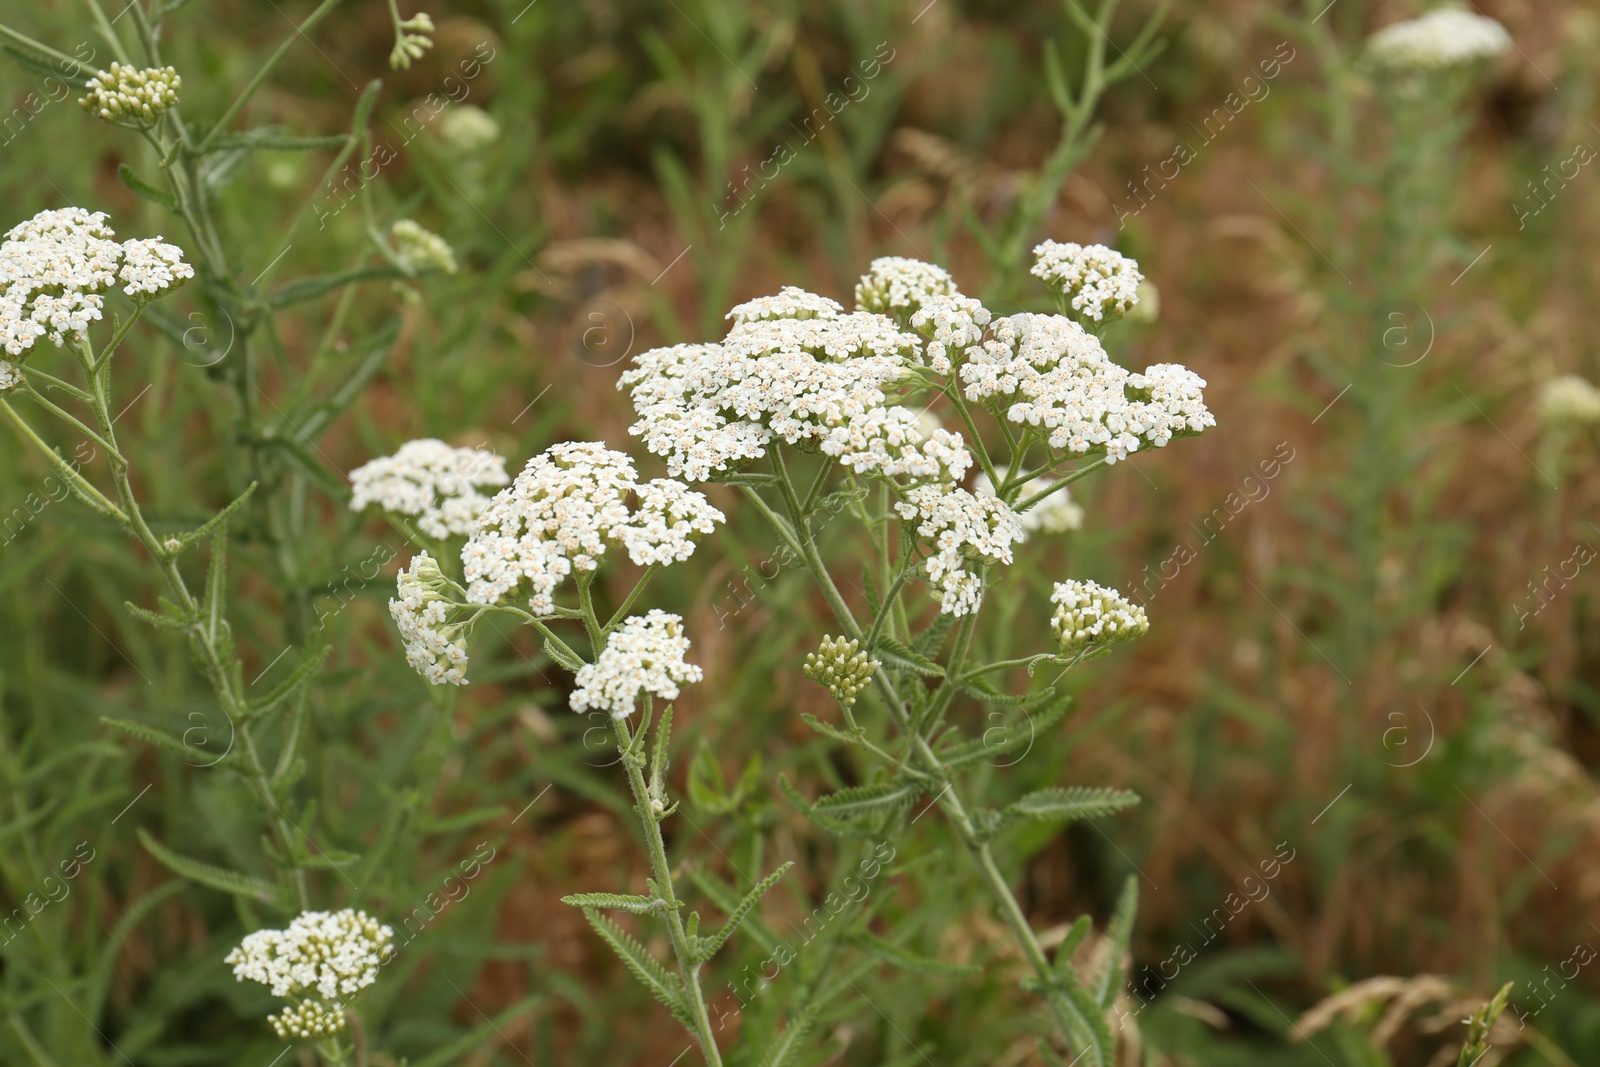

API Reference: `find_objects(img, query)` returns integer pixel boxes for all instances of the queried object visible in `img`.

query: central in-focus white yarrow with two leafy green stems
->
[377,243,1214,1065]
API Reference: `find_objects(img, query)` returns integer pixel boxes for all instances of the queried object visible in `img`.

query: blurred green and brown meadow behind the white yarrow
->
[0,0,1600,1067]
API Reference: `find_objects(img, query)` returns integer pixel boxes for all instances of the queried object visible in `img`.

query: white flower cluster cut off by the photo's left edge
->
[0,208,194,355]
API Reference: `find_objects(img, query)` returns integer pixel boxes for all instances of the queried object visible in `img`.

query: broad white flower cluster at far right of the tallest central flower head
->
[960,314,1216,462]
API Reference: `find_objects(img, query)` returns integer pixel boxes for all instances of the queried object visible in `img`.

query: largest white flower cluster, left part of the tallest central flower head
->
[619,307,922,482]
